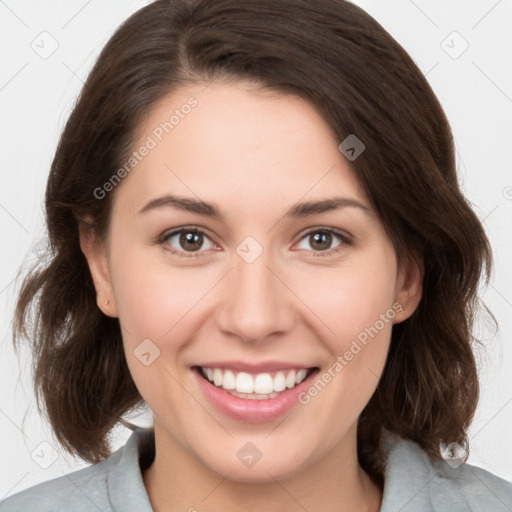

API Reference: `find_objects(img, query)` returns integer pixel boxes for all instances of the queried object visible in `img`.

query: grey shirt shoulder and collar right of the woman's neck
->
[381,434,512,512]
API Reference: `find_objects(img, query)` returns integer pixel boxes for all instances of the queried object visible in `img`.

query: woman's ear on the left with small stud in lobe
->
[78,222,118,318]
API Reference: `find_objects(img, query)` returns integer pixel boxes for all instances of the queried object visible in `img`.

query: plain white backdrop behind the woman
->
[0,0,512,499]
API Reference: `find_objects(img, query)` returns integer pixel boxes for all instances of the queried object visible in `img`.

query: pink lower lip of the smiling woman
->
[192,369,318,423]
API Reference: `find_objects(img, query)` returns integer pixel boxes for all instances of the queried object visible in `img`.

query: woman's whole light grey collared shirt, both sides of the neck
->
[0,429,512,512]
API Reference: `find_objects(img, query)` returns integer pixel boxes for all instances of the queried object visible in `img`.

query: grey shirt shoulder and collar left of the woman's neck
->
[0,429,151,512]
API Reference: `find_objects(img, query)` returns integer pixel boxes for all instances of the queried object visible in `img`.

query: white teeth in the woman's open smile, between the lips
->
[194,366,318,400]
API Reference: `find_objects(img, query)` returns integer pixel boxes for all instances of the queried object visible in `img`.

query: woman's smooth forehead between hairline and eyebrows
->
[112,82,365,215]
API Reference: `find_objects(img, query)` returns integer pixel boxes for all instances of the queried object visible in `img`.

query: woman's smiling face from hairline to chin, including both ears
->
[82,82,421,481]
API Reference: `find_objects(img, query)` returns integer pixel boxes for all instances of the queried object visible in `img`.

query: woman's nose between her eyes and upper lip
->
[216,245,297,343]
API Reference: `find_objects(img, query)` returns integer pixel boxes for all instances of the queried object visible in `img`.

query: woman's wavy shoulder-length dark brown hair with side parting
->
[14,0,491,482]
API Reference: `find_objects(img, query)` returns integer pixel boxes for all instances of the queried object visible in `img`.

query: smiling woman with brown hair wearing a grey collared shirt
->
[0,0,512,512]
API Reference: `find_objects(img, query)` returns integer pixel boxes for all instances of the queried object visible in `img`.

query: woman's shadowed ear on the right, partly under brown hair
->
[393,251,425,324]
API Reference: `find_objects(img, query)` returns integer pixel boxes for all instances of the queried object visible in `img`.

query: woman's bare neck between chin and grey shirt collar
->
[143,424,382,512]
